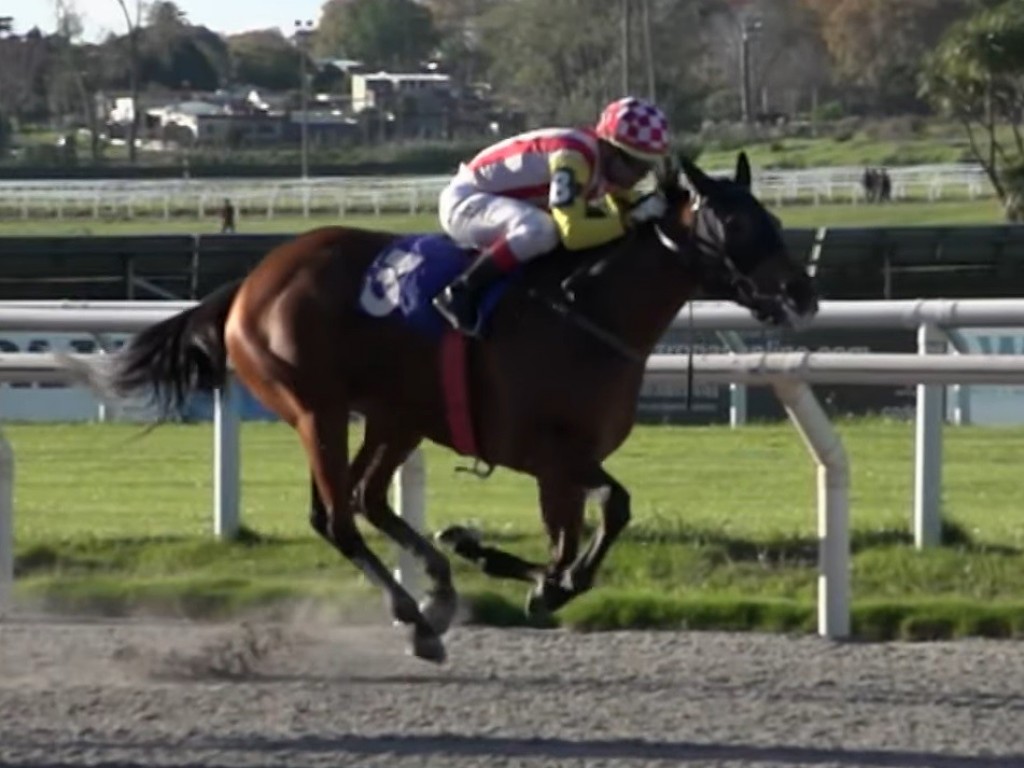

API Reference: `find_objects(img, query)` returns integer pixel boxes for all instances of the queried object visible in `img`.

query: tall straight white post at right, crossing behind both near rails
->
[913,323,946,549]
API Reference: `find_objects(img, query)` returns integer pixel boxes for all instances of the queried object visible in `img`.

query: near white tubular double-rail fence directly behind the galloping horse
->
[0,300,1024,637]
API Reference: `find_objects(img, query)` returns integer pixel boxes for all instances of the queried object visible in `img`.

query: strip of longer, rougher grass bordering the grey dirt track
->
[16,531,1024,641]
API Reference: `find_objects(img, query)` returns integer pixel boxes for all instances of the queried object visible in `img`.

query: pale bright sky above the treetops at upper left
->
[0,0,324,40]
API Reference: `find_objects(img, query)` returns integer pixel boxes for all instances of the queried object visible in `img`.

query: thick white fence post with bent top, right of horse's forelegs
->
[774,379,850,639]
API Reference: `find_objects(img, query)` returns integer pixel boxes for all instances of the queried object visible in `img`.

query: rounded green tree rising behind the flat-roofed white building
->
[313,0,438,72]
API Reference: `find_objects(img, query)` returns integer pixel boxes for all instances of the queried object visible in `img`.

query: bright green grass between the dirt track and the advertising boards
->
[5,420,1024,637]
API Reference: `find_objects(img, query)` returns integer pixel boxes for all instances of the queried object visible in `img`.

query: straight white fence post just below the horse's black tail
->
[213,373,242,539]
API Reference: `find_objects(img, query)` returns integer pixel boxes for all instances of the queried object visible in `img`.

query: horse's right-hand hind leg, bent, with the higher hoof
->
[352,428,458,635]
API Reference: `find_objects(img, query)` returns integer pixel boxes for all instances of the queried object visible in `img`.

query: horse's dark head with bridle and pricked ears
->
[657,153,818,326]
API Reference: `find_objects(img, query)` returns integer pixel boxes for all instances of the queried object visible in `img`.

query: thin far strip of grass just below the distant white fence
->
[0,200,1004,237]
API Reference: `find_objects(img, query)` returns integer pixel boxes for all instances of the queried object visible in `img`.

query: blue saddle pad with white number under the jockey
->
[359,234,516,337]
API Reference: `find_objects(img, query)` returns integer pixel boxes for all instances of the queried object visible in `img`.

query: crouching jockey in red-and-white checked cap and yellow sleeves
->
[433,97,669,336]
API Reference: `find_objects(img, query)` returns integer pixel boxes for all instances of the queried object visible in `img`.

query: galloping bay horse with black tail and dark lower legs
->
[75,154,817,663]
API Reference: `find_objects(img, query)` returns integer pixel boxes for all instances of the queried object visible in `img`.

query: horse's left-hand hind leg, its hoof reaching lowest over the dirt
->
[295,407,444,662]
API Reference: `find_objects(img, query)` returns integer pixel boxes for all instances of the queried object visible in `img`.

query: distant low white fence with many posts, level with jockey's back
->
[0,164,992,220]
